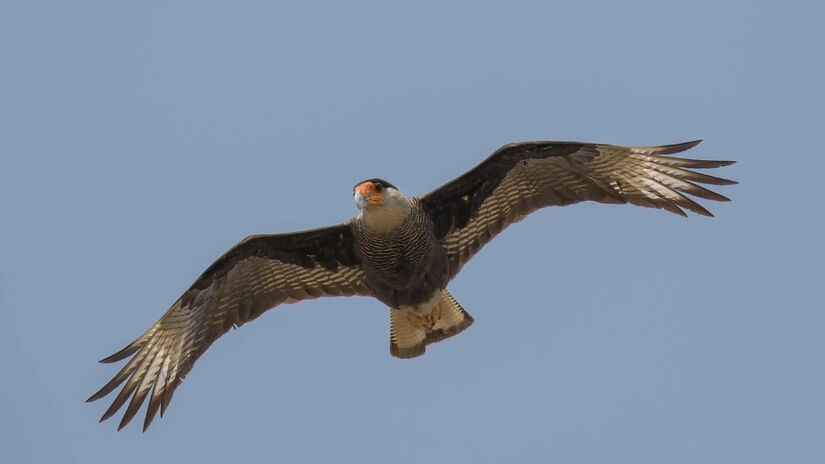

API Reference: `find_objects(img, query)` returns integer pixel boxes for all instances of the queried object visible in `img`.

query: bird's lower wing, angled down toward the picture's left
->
[87,224,370,430]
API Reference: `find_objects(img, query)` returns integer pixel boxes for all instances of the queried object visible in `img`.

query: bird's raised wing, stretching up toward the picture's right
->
[422,140,736,277]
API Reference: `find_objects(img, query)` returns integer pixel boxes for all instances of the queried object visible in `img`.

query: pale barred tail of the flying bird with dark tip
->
[390,290,473,358]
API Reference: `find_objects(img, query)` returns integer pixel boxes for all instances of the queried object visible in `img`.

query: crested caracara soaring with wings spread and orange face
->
[87,141,736,431]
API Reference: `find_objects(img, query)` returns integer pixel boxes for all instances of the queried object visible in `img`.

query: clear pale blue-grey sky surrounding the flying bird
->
[0,0,825,464]
